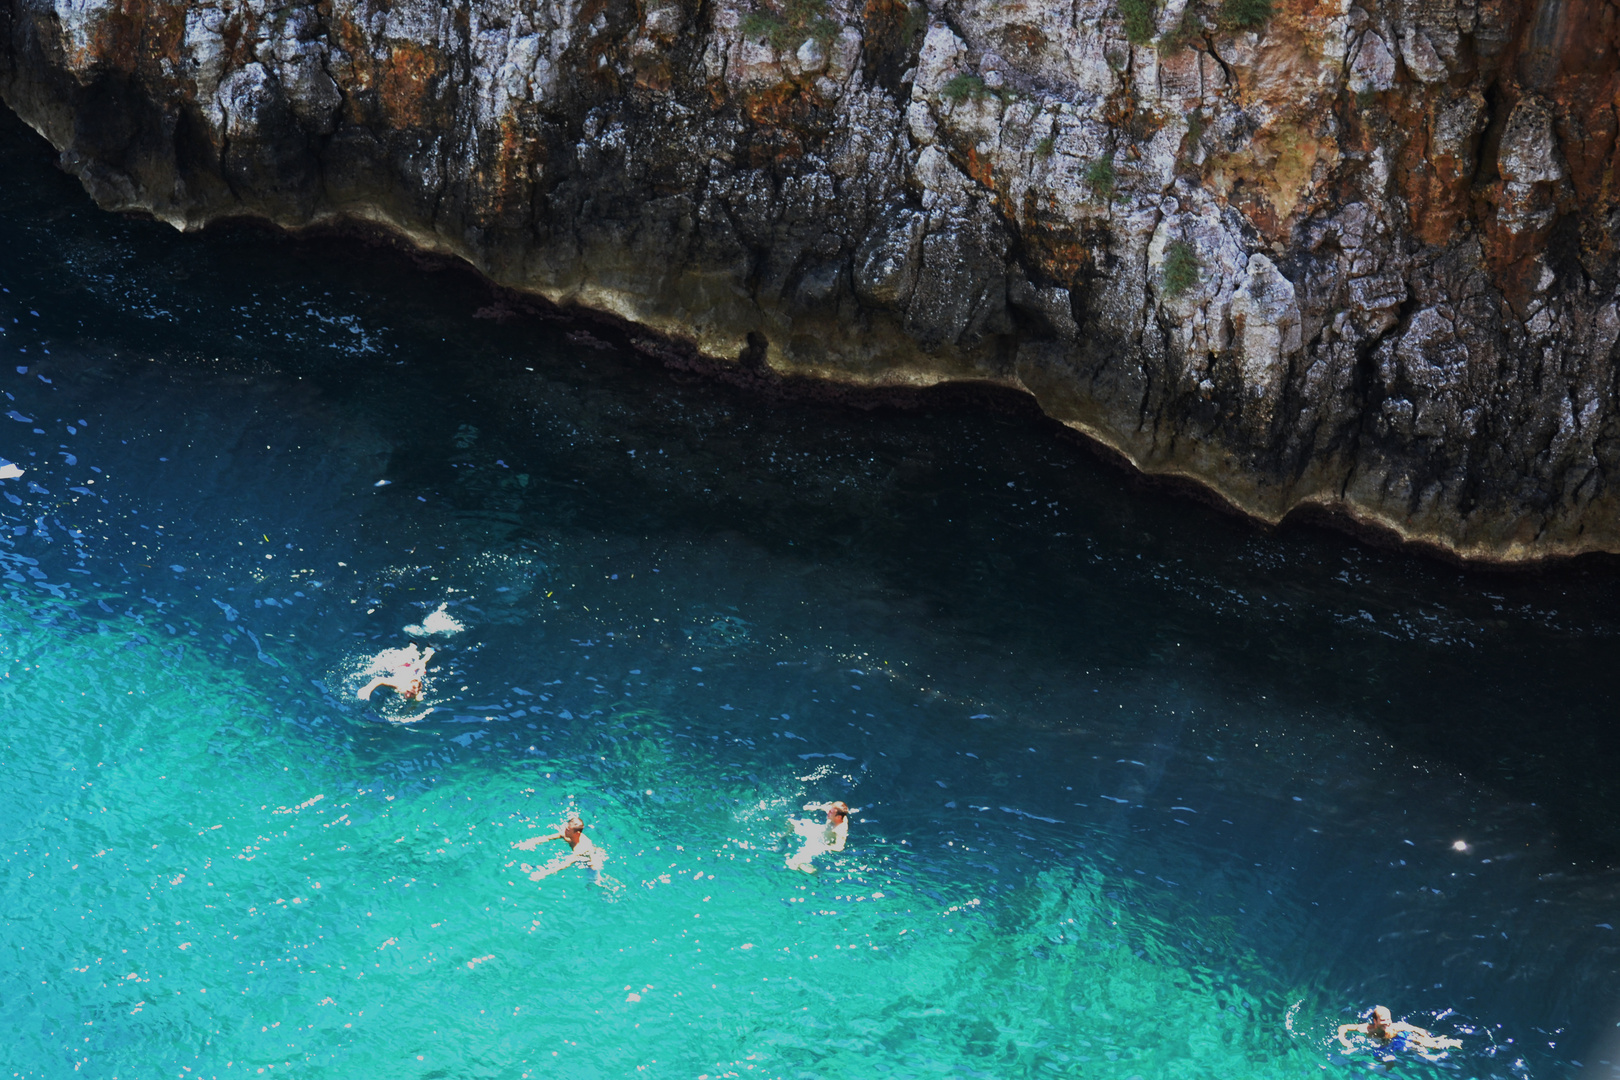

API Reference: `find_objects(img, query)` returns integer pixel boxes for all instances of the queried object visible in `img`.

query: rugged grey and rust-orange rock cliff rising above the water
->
[9,0,1620,562]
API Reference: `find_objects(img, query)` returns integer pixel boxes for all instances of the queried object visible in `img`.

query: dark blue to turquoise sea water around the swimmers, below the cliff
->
[0,111,1620,1080]
